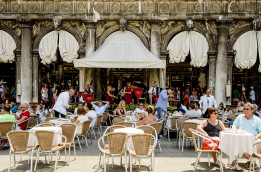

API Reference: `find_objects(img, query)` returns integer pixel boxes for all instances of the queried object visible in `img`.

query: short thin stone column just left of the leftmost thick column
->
[16,52,22,103]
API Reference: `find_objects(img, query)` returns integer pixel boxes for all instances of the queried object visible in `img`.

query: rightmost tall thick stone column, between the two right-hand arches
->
[215,19,230,104]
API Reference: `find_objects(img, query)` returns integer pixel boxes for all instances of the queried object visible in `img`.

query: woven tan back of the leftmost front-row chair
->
[7,131,30,152]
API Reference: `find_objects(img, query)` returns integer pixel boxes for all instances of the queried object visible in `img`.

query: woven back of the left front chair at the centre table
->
[107,133,127,155]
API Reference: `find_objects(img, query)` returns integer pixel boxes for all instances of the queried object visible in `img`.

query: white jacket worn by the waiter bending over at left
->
[53,91,70,115]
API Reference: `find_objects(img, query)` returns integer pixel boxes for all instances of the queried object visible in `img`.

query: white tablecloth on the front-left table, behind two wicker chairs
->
[28,127,62,146]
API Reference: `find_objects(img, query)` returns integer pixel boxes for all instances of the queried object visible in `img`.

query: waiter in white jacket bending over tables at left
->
[53,89,74,118]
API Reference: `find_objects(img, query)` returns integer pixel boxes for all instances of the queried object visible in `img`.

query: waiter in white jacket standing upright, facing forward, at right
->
[199,89,217,114]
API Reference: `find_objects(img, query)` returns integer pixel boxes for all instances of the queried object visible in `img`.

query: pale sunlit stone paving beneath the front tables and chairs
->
[0,134,254,172]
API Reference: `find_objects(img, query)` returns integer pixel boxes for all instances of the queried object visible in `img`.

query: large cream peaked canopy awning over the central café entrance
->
[73,31,166,68]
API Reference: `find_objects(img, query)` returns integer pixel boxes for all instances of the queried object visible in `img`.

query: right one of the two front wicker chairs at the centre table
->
[128,134,157,171]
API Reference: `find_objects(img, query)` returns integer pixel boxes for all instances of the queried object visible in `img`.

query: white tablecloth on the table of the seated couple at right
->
[219,132,255,164]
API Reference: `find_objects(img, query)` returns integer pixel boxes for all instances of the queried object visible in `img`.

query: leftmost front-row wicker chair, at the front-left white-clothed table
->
[7,131,36,172]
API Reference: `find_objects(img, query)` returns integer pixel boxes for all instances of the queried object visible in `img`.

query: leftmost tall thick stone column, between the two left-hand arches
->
[21,22,33,103]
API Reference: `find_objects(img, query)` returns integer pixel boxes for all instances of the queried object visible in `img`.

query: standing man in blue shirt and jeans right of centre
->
[155,88,174,135]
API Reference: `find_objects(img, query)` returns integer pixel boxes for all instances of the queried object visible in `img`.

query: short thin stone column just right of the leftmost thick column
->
[32,52,39,103]
